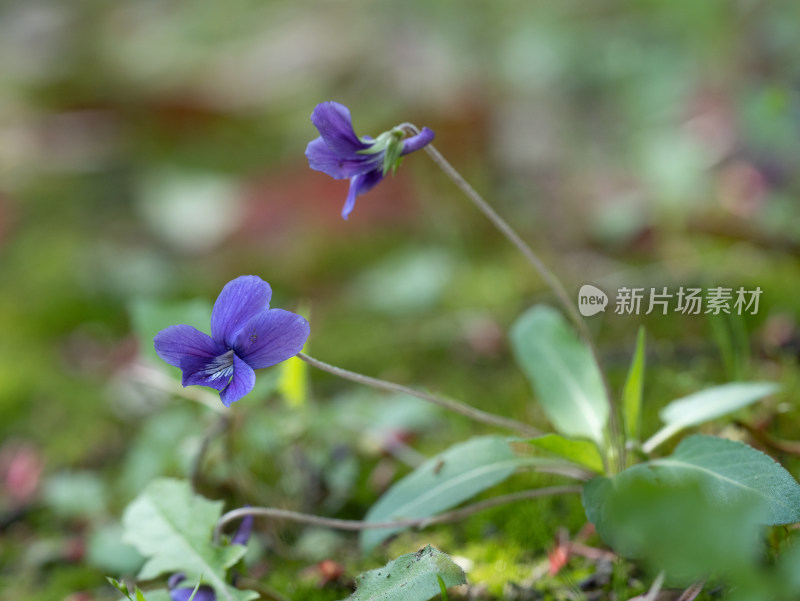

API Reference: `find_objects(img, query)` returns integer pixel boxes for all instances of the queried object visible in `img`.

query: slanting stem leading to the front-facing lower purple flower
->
[297,353,541,436]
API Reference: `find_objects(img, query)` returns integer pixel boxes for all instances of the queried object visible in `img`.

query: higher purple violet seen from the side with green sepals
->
[306,102,434,219]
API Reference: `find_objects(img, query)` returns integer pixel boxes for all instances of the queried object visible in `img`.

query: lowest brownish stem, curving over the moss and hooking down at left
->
[214,485,582,543]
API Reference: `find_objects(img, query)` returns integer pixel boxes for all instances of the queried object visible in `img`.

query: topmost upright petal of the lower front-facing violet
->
[211,275,272,347]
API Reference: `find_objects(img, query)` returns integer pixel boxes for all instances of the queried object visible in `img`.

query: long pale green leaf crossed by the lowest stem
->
[361,436,526,551]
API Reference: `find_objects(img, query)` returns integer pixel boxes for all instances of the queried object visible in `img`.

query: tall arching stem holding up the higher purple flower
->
[398,123,625,470]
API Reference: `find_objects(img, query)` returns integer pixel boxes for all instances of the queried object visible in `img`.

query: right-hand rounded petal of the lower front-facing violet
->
[233,309,310,369]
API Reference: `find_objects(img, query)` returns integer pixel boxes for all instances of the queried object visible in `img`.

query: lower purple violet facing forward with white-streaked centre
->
[153,275,309,407]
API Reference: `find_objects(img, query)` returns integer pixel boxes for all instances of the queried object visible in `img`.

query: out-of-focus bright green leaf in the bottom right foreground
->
[583,466,764,586]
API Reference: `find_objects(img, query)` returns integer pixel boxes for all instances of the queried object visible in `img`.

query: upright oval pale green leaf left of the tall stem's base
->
[511,305,609,448]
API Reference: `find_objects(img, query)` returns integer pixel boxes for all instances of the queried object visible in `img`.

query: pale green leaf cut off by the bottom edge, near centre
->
[347,545,467,601]
